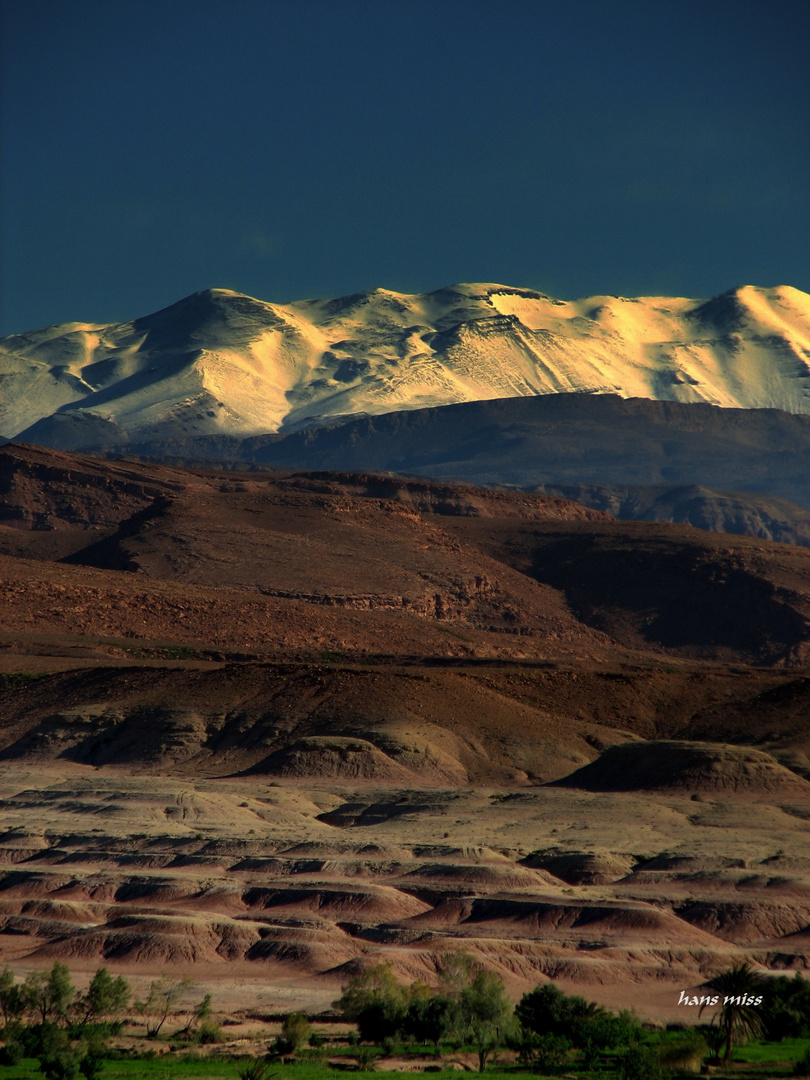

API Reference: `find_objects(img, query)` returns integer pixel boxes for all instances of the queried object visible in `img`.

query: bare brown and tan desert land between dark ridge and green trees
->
[0,444,810,1020]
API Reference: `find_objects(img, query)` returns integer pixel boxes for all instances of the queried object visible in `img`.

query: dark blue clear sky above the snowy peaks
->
[0,0,810,333]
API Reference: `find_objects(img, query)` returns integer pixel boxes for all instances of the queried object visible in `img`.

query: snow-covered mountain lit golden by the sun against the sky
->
[0,284,810,448]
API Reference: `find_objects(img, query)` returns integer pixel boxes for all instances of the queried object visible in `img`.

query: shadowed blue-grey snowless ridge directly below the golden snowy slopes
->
[49,394,810,505]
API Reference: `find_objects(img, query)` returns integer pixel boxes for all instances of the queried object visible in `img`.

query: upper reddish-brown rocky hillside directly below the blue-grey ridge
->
[0,445,810,664]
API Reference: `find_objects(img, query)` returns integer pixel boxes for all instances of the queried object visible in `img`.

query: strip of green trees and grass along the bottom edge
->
[0,951,810,1080]
